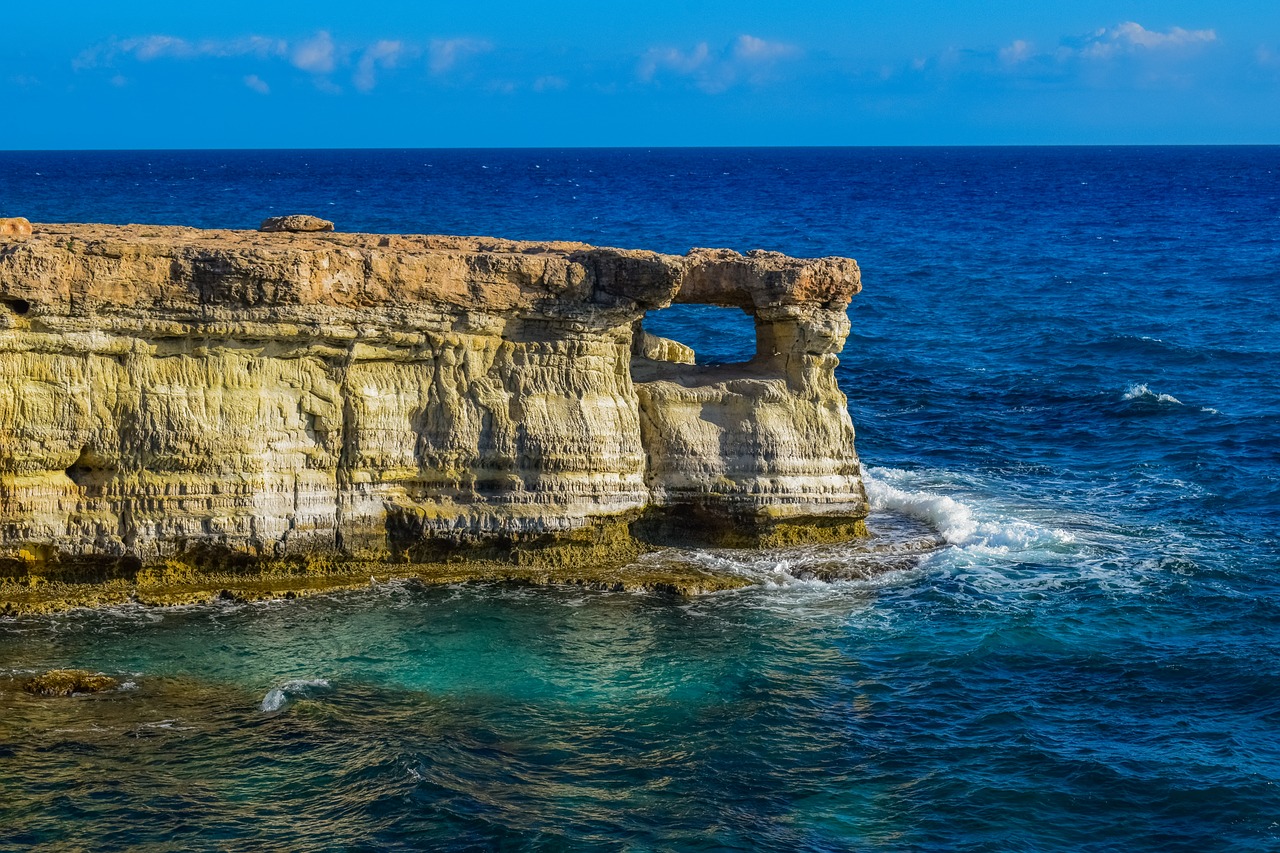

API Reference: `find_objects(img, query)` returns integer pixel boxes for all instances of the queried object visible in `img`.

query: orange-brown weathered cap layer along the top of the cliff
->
[0,223,860,314]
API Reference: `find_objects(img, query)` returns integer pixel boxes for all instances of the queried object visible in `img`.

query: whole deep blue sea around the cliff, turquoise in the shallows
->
[0,147,1280,853]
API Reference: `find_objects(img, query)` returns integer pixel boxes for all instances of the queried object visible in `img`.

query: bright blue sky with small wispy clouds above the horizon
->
[0,0,1280,149]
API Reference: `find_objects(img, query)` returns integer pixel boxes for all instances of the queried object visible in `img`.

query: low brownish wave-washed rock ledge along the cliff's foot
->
[0,512,946,619]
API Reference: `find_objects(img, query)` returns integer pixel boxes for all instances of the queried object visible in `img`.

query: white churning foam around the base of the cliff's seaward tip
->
[641,467,1153,604]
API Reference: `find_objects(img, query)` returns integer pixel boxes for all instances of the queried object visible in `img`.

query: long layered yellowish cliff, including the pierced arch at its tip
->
[0,223,867,589]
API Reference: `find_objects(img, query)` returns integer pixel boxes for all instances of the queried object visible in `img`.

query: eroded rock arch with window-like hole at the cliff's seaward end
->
[632,248,867,544]
